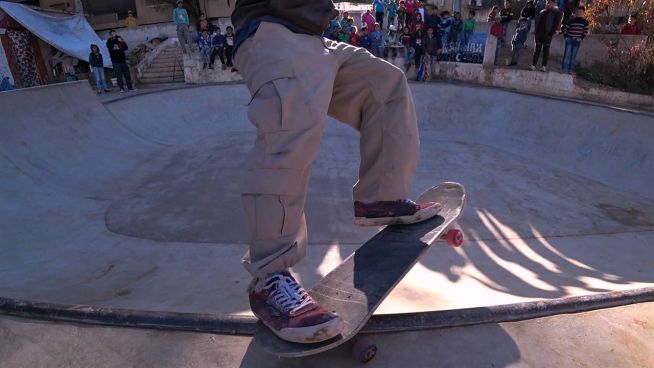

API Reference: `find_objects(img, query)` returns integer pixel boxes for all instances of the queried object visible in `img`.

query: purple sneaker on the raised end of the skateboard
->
[354,199,442,226]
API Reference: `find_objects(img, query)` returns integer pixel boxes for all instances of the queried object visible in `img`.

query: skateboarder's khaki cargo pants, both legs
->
[236,22,419,277]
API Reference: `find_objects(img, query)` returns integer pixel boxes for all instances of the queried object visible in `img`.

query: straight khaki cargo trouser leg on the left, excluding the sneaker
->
[236,23,338,278]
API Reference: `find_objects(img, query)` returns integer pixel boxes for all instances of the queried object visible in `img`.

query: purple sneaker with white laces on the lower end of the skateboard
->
[249,271,344,344]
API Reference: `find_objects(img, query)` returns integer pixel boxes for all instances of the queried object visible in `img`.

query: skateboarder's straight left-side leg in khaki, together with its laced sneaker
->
[236,23,343,343]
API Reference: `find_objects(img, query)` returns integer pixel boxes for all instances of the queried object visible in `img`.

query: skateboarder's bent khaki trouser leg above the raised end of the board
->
[329,43,420,201]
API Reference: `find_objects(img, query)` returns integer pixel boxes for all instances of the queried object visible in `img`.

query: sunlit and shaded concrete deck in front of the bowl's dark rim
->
[0,303,654,368]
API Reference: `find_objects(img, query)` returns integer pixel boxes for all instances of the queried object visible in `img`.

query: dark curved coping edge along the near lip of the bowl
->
[0,287,654,335]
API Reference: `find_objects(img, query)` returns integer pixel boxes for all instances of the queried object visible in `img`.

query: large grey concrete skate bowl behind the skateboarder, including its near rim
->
[0,82,654,333]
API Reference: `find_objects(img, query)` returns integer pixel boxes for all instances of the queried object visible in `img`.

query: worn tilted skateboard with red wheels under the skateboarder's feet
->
[254,183,466,363]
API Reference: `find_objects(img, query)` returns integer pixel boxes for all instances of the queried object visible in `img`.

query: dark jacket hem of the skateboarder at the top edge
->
[232,0,338,35]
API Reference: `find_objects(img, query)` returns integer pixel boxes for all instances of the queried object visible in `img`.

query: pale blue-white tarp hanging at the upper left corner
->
[0,1,111,67]
